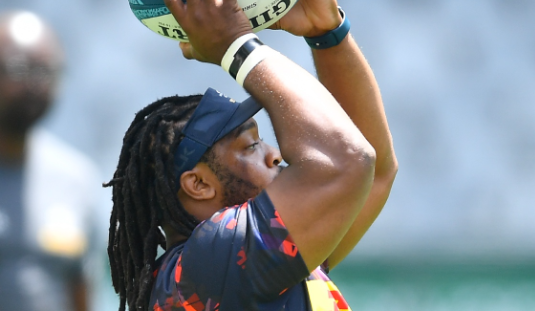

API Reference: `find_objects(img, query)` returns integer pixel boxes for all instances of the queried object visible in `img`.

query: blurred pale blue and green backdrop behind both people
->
[0,0,535,311]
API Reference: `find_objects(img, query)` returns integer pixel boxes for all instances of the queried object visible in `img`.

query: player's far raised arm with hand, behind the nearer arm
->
[277,0,398,268]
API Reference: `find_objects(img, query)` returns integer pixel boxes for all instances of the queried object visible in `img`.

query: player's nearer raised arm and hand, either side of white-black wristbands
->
[166,0,375,271]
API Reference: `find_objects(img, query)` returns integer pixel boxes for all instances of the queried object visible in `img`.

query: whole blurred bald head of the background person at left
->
[0,11,64,162]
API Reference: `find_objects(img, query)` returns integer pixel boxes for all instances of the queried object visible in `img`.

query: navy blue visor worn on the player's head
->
[175,88,262,188]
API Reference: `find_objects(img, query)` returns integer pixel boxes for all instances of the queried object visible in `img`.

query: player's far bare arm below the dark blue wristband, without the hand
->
[312,34,398,268]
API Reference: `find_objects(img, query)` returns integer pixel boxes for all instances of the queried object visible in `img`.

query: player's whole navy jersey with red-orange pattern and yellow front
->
[150,192,351,311]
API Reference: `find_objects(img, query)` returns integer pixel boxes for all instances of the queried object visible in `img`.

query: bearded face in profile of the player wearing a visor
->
[210,118,282,206]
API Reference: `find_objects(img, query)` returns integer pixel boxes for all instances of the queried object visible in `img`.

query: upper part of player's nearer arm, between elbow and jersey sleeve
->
[267,161,371,271]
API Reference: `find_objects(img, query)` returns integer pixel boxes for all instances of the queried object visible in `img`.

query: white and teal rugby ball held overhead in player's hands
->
[128,0,298,42]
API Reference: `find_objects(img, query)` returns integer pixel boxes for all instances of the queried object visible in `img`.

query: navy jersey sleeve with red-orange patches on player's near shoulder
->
[176,192,309,309]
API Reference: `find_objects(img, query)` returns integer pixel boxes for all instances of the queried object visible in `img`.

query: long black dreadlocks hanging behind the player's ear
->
[103,95,211,311]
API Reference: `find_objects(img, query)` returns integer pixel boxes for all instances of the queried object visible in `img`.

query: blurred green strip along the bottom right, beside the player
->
[331,261,535,311]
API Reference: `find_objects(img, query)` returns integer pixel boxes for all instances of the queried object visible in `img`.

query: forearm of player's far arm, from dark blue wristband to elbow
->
[312,34,397,176]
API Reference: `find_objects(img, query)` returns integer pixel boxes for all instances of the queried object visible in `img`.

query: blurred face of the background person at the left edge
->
[0,23,63,134]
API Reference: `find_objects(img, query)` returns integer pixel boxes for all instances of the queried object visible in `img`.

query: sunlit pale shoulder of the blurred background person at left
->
[24,128,104,230]
